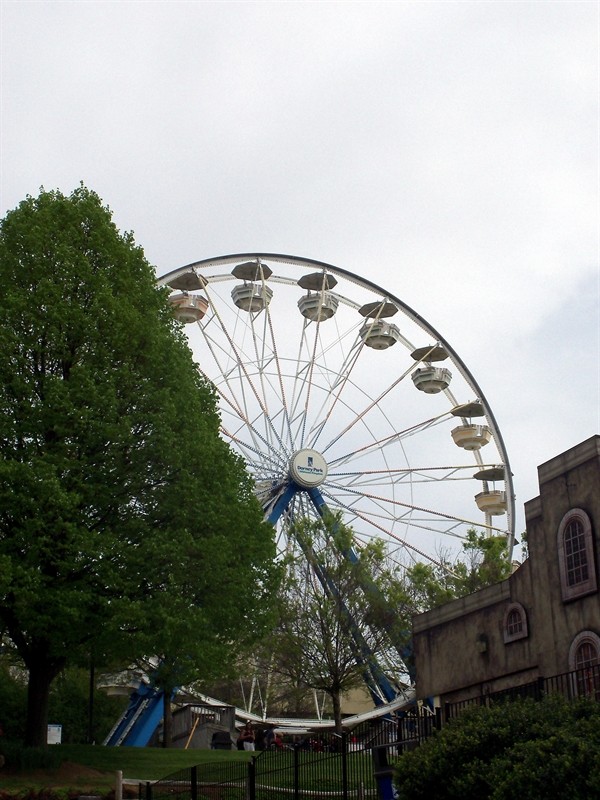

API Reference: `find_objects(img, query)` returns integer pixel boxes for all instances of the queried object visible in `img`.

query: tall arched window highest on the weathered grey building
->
[557,508,597,600]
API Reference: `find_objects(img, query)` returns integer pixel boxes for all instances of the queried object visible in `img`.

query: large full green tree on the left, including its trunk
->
[0,186,276,744]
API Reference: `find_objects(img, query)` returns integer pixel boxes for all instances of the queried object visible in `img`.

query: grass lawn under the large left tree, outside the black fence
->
[0,744,251,797]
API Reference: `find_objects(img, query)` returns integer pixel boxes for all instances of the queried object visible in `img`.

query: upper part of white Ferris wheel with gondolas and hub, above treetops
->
[159,253,514,565]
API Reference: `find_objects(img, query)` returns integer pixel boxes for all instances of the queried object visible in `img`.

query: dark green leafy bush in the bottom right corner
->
[396,696,600,800]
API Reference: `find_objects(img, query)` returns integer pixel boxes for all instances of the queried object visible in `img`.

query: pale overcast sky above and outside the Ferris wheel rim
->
[0,0,600,529]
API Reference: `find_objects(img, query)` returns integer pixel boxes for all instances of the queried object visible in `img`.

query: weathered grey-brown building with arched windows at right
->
[413,436,600,705]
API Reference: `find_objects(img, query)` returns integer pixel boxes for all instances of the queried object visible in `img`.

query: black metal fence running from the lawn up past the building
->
[140,665,600,800]
